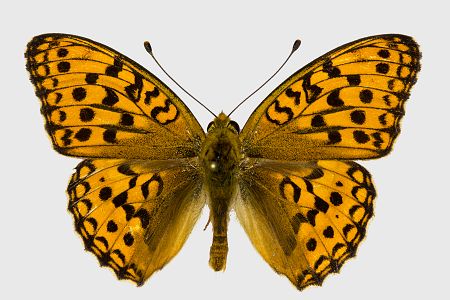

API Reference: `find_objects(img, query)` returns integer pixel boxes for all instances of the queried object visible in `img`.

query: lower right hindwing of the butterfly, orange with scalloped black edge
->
[235,159,375,289]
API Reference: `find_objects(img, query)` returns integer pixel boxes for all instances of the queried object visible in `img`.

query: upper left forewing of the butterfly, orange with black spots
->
[25,34,204,160]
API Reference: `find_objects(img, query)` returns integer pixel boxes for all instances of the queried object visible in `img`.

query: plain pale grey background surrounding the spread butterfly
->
[0,0,450,299]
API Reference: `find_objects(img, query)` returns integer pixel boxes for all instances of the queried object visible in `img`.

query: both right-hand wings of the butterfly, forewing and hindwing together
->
[235,35,420,289]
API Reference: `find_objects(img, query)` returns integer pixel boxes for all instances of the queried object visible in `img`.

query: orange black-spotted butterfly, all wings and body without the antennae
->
[25,34,420,290]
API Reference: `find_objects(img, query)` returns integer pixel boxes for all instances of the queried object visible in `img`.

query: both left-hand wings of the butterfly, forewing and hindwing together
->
[25,34,205,285]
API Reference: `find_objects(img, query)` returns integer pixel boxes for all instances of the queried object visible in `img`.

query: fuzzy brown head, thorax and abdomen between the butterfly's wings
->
[200,113,241,271]
